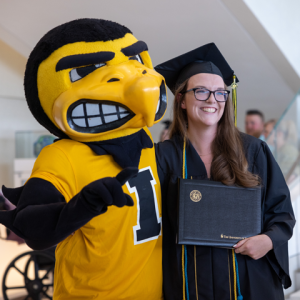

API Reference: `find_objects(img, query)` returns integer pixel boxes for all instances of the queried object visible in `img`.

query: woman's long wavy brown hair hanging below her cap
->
[170,79,260,187]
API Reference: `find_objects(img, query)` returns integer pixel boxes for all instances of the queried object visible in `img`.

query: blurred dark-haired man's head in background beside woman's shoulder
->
[245,109,265,141]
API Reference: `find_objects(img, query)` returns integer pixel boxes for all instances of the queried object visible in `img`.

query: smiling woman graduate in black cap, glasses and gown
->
[155,43,295,300]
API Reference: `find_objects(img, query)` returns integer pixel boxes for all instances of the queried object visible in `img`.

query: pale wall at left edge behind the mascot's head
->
[0,41,42,187]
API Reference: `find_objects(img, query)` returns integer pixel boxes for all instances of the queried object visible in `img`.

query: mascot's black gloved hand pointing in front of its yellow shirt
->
[80,168,138,213]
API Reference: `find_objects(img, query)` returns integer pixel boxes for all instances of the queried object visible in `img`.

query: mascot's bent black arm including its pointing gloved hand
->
[0,174,133,250]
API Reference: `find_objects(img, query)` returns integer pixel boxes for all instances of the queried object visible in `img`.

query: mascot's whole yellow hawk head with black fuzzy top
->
[24,19,167,142]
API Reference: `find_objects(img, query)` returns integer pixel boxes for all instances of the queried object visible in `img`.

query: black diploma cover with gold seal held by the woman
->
[177,178,261,248]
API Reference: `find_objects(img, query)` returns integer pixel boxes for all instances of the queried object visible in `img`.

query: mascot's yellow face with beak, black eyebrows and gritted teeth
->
[37,33,167,142]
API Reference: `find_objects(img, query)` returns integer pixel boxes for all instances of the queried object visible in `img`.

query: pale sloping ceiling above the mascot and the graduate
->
[0,0,300,136]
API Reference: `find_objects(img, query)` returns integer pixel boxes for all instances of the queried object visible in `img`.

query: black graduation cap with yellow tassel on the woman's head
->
[154,43,238,125]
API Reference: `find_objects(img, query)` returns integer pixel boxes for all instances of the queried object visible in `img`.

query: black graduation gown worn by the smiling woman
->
[156,134,295,300]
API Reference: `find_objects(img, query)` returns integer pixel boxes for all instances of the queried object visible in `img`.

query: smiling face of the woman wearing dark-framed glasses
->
[181,73,226,127]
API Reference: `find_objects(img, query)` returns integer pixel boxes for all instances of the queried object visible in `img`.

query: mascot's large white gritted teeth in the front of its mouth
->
[71,103,130,128]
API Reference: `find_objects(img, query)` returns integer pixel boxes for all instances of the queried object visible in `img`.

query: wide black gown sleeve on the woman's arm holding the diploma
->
[253,143,295,288]
